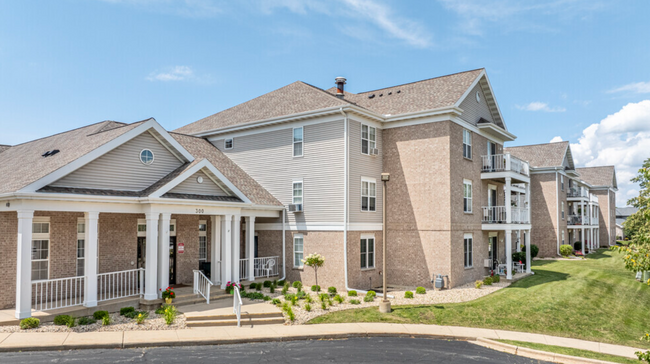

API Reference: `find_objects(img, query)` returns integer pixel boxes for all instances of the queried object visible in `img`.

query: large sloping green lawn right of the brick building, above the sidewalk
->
[310,250,650,347]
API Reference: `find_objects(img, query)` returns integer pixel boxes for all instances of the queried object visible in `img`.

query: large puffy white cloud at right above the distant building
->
[571,100,650,206]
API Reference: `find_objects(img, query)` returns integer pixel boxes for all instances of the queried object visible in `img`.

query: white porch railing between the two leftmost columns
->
[32,277,85,311]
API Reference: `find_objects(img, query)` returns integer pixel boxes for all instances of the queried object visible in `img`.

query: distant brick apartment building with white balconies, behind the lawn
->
[506,142,617,257]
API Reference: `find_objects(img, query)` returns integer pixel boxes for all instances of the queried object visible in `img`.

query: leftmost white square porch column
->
[15,211,34,319]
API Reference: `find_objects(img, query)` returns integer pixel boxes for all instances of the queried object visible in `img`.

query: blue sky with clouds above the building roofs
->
[0,0,650,205]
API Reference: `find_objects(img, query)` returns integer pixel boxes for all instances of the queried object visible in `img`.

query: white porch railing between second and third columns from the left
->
[97,268,144,302]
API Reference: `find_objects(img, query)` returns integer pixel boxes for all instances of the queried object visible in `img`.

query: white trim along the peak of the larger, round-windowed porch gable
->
[17,118,194,192]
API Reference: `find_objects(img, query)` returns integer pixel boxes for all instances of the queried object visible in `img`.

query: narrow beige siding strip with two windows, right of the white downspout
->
[348,120,380,223]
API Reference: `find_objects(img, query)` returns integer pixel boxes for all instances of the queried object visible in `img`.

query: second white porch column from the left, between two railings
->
[84,212,99,307]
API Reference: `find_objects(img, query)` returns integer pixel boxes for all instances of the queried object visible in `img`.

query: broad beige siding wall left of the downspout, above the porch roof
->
[211,120,344,224]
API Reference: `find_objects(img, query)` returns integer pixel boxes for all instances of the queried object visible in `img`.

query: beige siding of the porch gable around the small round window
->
[51,132,183,191]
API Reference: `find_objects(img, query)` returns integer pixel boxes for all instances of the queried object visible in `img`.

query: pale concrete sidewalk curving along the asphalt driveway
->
[0,323,642,359]
